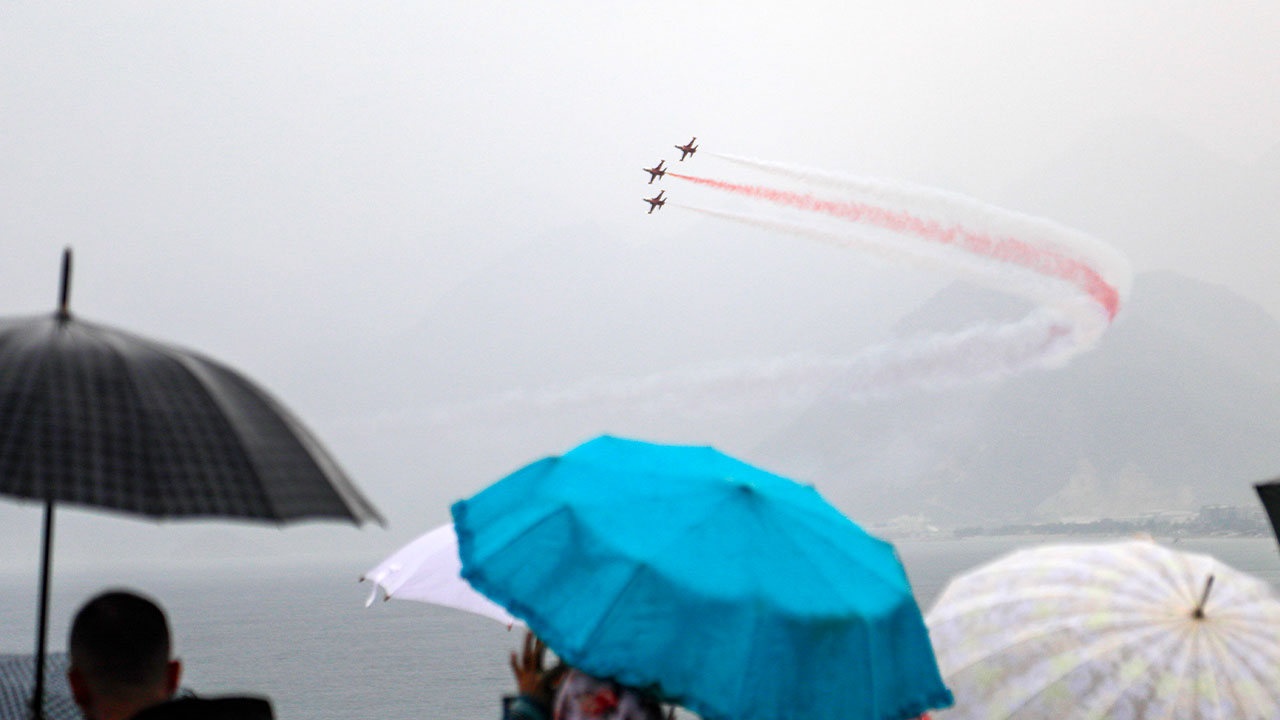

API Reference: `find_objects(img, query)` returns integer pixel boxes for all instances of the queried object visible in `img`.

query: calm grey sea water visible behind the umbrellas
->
[0,537,1280,720]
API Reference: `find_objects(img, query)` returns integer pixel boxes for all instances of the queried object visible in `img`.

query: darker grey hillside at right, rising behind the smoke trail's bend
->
[758,273,1280,527]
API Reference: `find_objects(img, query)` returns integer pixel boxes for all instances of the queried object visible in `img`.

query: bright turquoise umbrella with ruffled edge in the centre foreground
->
[453,437,951,720]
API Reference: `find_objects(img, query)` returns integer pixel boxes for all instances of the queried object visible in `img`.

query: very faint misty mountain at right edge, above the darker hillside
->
[998,117,1280,319]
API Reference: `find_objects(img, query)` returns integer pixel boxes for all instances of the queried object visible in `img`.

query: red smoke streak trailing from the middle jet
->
[667,172,1120,320]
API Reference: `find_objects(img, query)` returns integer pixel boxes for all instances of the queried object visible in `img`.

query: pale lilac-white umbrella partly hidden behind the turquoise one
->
[361,523,522,629]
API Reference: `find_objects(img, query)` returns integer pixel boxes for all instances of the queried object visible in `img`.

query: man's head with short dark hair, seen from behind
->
[67,591,182,720]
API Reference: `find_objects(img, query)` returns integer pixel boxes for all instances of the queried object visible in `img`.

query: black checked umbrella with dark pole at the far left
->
[0,250,383,717]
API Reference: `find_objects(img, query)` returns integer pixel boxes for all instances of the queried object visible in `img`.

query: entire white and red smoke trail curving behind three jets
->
[422,152,1132,420]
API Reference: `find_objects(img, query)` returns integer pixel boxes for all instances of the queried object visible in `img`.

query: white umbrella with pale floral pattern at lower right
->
[925,541,1280,720]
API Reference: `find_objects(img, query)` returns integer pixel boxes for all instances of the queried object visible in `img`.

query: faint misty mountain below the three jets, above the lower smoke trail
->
[309,213,937,411]
